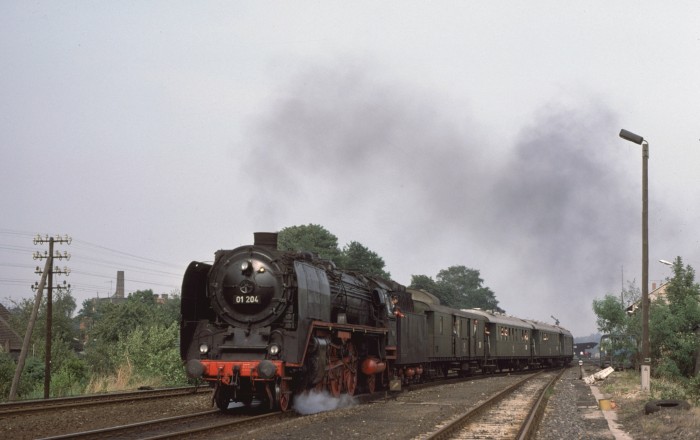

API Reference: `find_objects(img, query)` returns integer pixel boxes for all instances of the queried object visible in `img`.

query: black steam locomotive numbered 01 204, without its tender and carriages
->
[180,233,402,410]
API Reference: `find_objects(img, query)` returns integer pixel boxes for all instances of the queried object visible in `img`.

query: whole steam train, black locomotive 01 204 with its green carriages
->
[180,233,573,411]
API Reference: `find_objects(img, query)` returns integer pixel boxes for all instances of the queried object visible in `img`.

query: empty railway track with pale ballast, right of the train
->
[424,370,565,440]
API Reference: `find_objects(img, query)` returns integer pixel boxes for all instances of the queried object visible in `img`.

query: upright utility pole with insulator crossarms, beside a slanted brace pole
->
[32,235,72,399]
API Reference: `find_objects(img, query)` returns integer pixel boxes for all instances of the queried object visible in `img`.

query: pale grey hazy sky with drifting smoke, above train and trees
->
[0,0,700,336]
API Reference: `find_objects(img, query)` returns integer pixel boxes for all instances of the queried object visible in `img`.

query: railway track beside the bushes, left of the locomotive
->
[0,387,211,417]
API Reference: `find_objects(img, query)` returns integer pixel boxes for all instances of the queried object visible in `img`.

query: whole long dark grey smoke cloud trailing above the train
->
[241,64,639,334]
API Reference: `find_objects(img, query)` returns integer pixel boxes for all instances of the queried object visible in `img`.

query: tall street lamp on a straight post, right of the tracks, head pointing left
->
[620,129,651,392]
